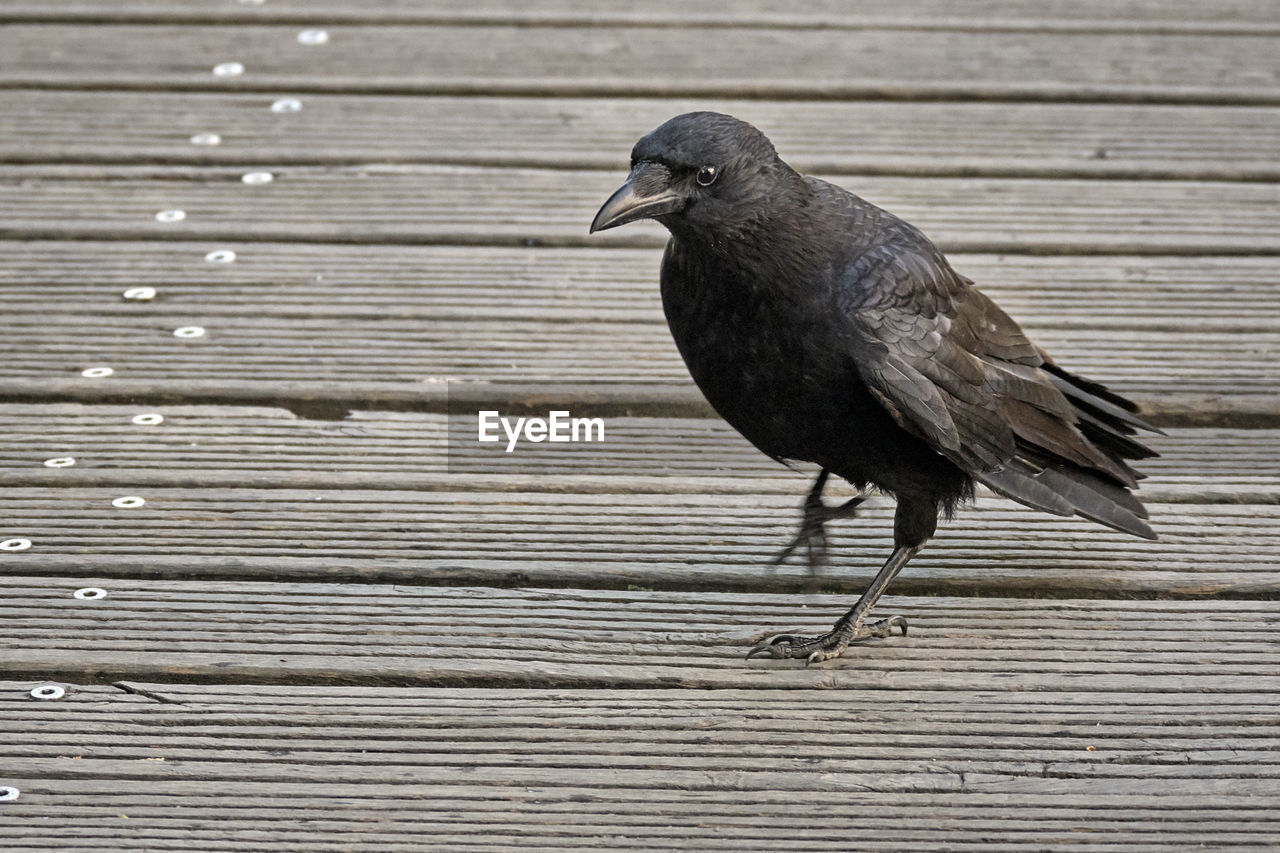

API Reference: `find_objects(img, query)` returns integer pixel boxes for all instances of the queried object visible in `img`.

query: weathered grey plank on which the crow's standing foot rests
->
[0,576,1280,686]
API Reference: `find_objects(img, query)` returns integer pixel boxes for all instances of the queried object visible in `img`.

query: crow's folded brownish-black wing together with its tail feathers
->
[837,207,1155,538]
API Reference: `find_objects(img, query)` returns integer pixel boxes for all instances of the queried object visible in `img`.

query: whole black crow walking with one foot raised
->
[591,113,1160,662]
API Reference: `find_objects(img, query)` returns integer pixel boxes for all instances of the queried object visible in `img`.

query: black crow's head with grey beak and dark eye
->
[591,113,800,234]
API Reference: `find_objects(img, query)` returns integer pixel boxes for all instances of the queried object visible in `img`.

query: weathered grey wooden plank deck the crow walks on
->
[0,0,1280,853]
